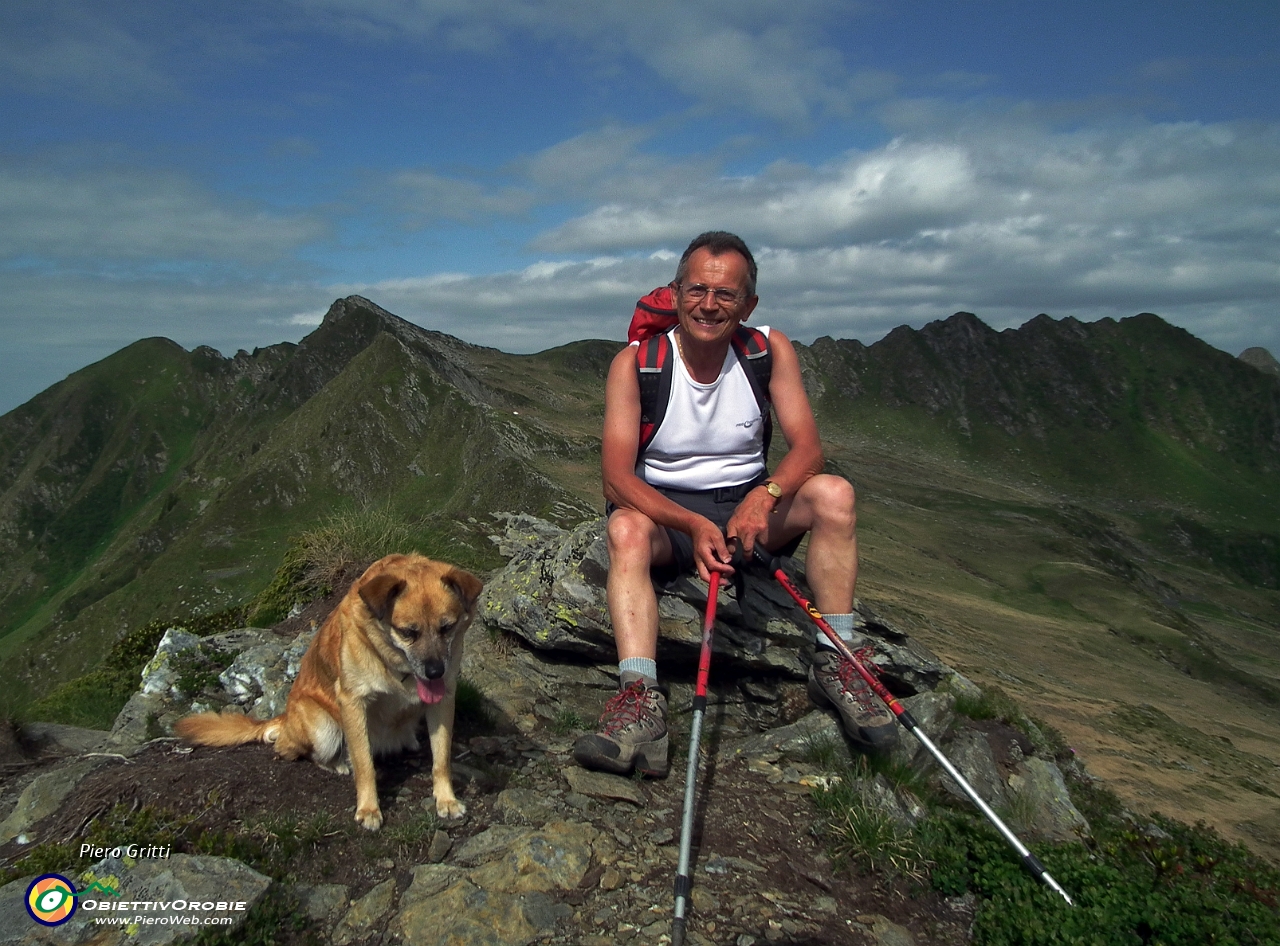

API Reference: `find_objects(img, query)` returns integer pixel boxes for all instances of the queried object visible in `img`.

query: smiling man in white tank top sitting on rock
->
[573,232,897,776]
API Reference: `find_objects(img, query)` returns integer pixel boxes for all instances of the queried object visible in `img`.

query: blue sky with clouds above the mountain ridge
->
[0,0,1280,411]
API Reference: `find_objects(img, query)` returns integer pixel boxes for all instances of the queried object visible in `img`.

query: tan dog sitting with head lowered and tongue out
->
[174,554,483,831]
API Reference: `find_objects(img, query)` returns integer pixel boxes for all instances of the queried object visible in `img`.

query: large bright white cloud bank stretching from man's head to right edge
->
[522,123,1280,334]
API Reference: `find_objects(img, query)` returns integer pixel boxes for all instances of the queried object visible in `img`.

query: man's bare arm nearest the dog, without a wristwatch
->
[600,346,737,580]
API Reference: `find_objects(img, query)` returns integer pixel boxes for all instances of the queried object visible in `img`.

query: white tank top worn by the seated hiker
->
[636,325,769,489]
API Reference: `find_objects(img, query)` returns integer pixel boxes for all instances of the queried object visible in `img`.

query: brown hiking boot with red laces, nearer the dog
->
[573,673,671,778]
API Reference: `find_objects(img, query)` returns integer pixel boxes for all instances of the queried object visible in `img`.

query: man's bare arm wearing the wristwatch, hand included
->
[728,329,823,556]
